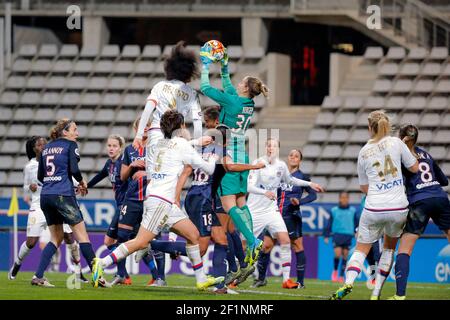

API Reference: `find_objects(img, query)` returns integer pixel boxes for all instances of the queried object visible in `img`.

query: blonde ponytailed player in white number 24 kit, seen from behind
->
[331,110,419,300]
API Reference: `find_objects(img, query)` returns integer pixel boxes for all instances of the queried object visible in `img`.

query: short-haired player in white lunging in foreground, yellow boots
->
[92,110,224,290]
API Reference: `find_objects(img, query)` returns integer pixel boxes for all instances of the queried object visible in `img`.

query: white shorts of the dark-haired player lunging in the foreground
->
[141,197,188,235]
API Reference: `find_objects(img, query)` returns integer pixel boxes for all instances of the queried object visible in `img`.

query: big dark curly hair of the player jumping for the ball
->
[164,41,199,83]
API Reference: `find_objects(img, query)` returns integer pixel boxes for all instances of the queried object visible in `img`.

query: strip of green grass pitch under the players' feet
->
[0,272,450,300]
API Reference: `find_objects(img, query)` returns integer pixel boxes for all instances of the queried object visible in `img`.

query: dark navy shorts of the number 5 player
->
[41,194,83,226]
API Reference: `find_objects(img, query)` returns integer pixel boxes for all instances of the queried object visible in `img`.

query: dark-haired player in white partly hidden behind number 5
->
[8,136,87,282]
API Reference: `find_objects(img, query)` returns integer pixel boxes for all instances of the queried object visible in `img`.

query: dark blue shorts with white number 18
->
[184,188,220,237]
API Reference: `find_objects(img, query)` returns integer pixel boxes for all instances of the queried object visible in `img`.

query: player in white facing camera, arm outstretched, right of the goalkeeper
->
[247,139,324,289]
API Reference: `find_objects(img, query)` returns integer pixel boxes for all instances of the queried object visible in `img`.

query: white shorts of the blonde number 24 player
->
[357,209,408,243]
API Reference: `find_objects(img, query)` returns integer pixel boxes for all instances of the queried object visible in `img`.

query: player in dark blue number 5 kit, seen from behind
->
[31,119,107,287]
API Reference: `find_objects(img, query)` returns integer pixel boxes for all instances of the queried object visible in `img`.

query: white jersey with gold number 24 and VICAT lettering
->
[358,137,416,211]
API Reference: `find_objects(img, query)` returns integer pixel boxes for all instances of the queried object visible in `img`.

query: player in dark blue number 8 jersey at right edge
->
[391,124,450,300]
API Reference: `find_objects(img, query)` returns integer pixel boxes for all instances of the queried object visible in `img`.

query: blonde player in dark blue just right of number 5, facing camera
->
[88,134,129,284]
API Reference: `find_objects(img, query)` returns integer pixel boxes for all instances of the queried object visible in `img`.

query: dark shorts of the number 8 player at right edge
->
[404,198,450,235]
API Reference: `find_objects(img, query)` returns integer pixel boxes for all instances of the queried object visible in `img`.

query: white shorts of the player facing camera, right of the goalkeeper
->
[249,208,287,239]
